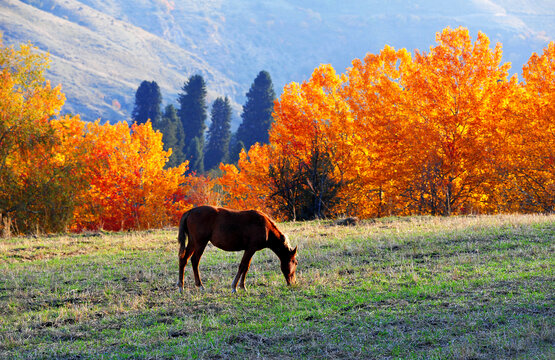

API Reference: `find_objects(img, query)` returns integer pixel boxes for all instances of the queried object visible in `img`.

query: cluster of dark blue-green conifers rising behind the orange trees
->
[132,71,276,174]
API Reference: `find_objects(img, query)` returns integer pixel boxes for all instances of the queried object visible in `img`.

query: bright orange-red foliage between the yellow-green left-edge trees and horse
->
[73,121,190,230]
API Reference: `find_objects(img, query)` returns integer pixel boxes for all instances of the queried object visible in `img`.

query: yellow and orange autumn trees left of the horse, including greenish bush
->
[0,35,217,234]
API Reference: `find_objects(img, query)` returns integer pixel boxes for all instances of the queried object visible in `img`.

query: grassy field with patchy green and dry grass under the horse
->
[0,215,555,359]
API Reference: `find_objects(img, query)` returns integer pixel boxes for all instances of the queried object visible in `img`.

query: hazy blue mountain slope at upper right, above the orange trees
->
[213,0,555,89]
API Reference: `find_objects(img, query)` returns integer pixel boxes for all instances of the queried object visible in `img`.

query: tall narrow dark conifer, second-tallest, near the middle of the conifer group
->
[178,75,206,172]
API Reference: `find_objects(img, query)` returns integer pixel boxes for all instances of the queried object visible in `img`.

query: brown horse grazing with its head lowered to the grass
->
[177,206,297,292]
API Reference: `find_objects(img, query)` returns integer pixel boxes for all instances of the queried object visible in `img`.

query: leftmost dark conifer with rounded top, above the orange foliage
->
[131,80,162,124]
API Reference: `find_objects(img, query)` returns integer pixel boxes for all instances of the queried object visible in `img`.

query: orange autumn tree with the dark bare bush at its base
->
[270,65,362,221]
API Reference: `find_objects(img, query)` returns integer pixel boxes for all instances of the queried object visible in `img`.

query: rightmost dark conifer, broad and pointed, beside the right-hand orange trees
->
[237,71,276,149]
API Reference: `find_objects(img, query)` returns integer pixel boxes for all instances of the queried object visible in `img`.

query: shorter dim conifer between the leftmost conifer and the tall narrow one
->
[156,105,185,167]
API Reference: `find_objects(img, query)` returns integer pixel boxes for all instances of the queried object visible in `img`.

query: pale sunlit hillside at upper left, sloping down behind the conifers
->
[0,0,241,121]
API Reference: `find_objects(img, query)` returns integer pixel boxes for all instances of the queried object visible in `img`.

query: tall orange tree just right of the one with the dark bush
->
[344,46,412,217]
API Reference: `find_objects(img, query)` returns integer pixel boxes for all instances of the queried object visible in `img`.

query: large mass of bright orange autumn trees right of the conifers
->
[220,28,555,217]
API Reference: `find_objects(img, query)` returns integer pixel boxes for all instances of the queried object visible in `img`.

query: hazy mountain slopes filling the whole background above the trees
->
[0,0,555,126]
